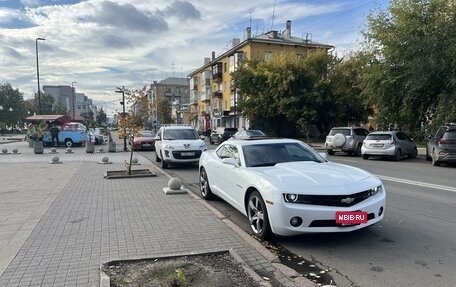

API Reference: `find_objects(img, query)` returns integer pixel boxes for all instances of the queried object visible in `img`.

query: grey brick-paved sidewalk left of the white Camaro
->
[0,142,314,287]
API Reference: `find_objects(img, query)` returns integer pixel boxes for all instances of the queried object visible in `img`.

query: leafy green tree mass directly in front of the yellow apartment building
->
[233,53,370,137]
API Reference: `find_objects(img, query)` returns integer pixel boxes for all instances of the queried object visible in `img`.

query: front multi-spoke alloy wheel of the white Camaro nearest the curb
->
[247,191,271,238]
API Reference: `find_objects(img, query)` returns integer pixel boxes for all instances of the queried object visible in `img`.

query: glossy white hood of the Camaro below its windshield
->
[257,161,381,193]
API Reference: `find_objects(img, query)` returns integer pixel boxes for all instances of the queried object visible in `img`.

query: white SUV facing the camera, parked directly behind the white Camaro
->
[155,125,207,169]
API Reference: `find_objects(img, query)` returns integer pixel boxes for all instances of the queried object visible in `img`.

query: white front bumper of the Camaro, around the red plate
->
[267,190,386,236]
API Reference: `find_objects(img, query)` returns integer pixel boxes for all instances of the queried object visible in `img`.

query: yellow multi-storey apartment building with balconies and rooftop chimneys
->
[189,21,334,132]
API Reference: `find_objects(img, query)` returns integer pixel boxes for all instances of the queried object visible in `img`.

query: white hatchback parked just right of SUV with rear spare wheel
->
[361,131,418,160]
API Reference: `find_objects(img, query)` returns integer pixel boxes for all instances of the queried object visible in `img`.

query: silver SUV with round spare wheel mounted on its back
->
[325,127,369,156]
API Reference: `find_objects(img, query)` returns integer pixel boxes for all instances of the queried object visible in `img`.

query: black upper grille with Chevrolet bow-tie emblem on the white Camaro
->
[295,189,372,207]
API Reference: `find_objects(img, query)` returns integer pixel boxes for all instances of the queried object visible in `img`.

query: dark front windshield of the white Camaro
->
[242,143,324,167]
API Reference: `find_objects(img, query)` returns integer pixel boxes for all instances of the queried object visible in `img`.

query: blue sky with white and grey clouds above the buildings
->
[0,0,388,115]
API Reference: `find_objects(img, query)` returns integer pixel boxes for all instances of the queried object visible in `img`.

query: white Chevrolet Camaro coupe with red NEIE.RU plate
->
[199,139,386,238]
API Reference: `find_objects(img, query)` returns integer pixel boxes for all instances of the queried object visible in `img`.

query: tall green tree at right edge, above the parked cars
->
[362,0,456,131]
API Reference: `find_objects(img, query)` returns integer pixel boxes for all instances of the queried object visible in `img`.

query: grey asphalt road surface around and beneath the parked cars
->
[142,145,456,287]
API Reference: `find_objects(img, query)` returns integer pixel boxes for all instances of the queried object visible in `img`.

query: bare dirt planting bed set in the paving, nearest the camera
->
[103,252,262,287]
